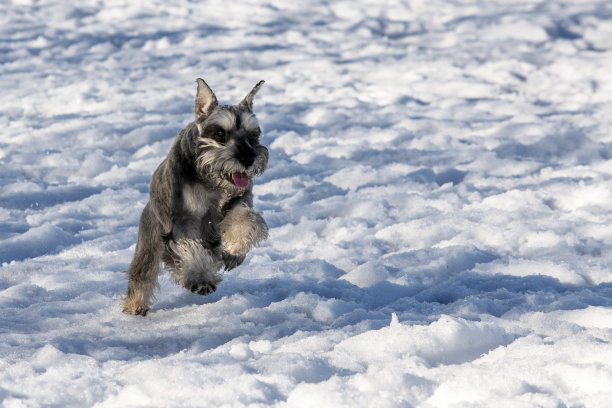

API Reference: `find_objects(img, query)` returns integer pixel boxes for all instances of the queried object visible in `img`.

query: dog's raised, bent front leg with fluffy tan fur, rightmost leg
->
[219,193,268,271]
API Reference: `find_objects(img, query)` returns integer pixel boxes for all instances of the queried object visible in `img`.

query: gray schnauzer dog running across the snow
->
[123,79,268,316]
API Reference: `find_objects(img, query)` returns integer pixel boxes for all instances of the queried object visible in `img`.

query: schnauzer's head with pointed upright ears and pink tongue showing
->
[195,79,268,195]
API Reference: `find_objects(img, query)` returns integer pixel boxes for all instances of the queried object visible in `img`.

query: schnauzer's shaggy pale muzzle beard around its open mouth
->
[196,139,268,195]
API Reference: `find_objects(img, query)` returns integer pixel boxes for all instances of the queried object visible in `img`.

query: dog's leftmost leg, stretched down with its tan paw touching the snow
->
[123,204,163,316]
